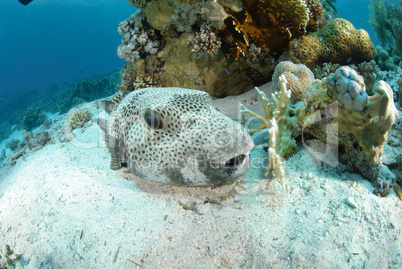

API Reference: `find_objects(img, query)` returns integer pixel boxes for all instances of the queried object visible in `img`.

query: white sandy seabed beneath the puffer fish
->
[0,87,402,268]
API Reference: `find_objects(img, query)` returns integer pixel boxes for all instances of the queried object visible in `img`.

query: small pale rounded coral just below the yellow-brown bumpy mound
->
[272,61,314,102]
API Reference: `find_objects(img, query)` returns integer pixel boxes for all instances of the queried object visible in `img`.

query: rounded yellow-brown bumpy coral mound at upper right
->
[290,18,374,68]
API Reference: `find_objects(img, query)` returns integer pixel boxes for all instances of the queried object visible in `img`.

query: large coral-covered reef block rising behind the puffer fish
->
[114,0,340,97]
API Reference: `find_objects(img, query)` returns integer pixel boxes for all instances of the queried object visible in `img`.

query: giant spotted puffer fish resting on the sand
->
[101,88,254,186]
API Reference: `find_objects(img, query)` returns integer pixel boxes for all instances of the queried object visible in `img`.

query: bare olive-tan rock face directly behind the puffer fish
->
[155,33,253,97]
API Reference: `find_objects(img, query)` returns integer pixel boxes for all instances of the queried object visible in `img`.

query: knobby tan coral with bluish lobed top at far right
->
[327,67,399,163]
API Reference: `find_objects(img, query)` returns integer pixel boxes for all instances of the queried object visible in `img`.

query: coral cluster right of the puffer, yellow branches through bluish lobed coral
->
[241,63,398,195]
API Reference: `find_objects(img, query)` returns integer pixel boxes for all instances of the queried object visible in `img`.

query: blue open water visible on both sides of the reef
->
[0,0,378,141]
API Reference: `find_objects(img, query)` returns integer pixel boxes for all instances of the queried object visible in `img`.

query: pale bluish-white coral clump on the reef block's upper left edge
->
[117,13,160,62]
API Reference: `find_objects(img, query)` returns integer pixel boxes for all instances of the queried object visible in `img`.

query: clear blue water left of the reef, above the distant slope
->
[0,0,135,99]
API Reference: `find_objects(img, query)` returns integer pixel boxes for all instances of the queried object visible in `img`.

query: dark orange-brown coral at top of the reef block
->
[225,0,316,58]
